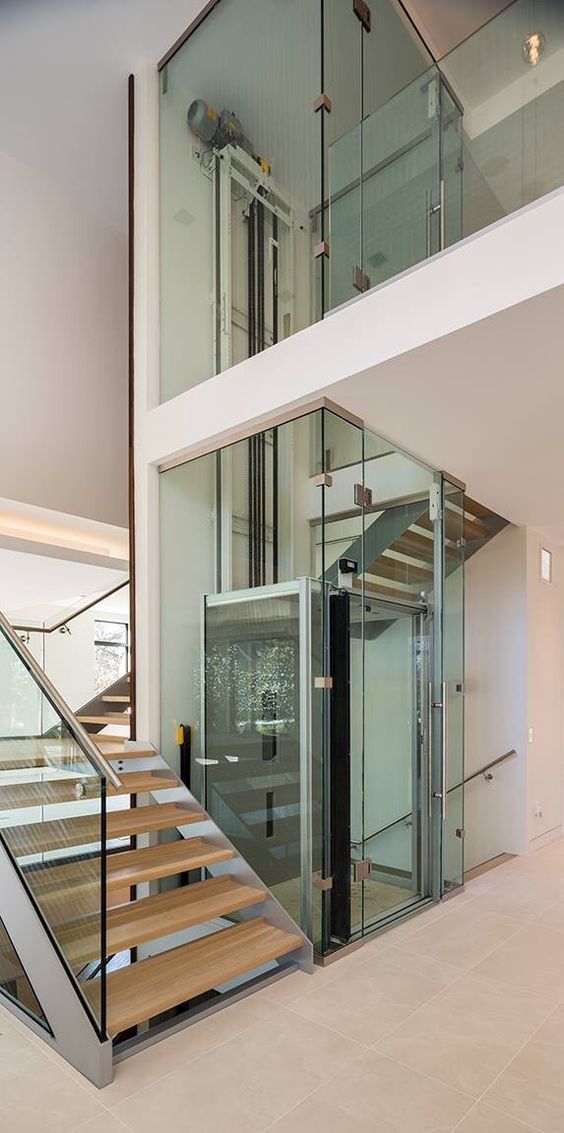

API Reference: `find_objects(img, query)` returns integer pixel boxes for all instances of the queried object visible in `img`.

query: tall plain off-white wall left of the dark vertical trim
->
[0,145,128,526]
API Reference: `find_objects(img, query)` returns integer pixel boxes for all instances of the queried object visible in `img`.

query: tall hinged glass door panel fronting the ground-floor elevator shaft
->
[362,429,439,931]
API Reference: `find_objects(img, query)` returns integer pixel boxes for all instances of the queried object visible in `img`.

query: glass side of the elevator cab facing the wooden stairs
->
[202,579,323,940]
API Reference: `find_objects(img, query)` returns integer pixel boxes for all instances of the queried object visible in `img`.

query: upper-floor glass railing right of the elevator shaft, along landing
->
[328,0,564,307]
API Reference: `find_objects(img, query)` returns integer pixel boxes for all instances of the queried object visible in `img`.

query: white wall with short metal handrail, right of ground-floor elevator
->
[464,527,528,869]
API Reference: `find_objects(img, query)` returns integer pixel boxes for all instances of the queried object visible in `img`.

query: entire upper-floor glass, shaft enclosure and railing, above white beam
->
[160,0,564,401]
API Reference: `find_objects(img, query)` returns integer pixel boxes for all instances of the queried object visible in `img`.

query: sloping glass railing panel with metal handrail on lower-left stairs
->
[0,615,121,1039]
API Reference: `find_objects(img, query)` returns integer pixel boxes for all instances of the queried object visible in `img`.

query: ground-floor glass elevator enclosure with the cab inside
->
[161,409,466,954]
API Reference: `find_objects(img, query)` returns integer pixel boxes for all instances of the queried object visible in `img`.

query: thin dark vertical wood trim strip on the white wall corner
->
[127,75,137,740]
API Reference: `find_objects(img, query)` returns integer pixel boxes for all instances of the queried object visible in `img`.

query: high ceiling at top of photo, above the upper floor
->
[0,0,506,231]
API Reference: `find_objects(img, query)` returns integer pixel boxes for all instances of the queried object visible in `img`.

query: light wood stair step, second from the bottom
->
[57,877,267,968]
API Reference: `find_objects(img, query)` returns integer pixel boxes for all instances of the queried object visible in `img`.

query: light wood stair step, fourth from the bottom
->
[3,802,206,858]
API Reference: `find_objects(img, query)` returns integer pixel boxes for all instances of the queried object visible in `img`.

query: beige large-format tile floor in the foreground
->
[5,841,564,1133]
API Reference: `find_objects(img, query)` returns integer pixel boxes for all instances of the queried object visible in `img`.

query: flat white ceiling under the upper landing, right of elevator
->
[330,287,564,545]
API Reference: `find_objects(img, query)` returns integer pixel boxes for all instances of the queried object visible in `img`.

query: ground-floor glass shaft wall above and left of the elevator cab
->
[160,414,323,792]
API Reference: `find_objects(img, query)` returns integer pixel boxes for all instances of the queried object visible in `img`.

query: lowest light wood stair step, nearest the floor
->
[91,917,301,1034]
